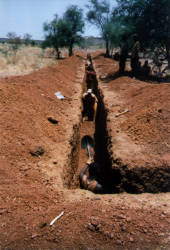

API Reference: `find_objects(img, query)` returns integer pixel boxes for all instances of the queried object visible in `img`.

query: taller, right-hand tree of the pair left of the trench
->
[60,5,84,56]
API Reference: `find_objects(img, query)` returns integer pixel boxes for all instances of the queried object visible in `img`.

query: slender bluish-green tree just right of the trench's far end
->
[87,0,113,56]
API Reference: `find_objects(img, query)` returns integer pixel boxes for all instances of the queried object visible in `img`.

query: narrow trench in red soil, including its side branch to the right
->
[65,53,170,194]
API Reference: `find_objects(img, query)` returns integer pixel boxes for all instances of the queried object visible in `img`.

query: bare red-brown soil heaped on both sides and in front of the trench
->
[0,50,170,249]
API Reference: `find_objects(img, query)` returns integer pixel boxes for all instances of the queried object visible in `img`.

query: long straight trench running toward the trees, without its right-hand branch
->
[67,53,121,193]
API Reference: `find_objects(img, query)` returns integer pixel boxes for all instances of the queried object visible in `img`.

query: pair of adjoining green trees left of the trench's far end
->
[43,5,84,56]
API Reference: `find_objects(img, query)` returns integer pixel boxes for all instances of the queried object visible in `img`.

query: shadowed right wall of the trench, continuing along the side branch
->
[93,58,170,193]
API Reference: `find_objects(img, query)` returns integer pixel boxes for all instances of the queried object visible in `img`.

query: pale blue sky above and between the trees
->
[0,0,115,40]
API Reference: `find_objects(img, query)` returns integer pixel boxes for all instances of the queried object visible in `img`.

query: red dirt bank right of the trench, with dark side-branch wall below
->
[94,52,170,193]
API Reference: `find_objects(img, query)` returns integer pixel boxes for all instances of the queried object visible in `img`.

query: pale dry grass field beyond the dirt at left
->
[0,44,57,77]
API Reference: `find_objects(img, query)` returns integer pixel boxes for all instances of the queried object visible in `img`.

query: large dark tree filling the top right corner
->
[114,0,170,67]
